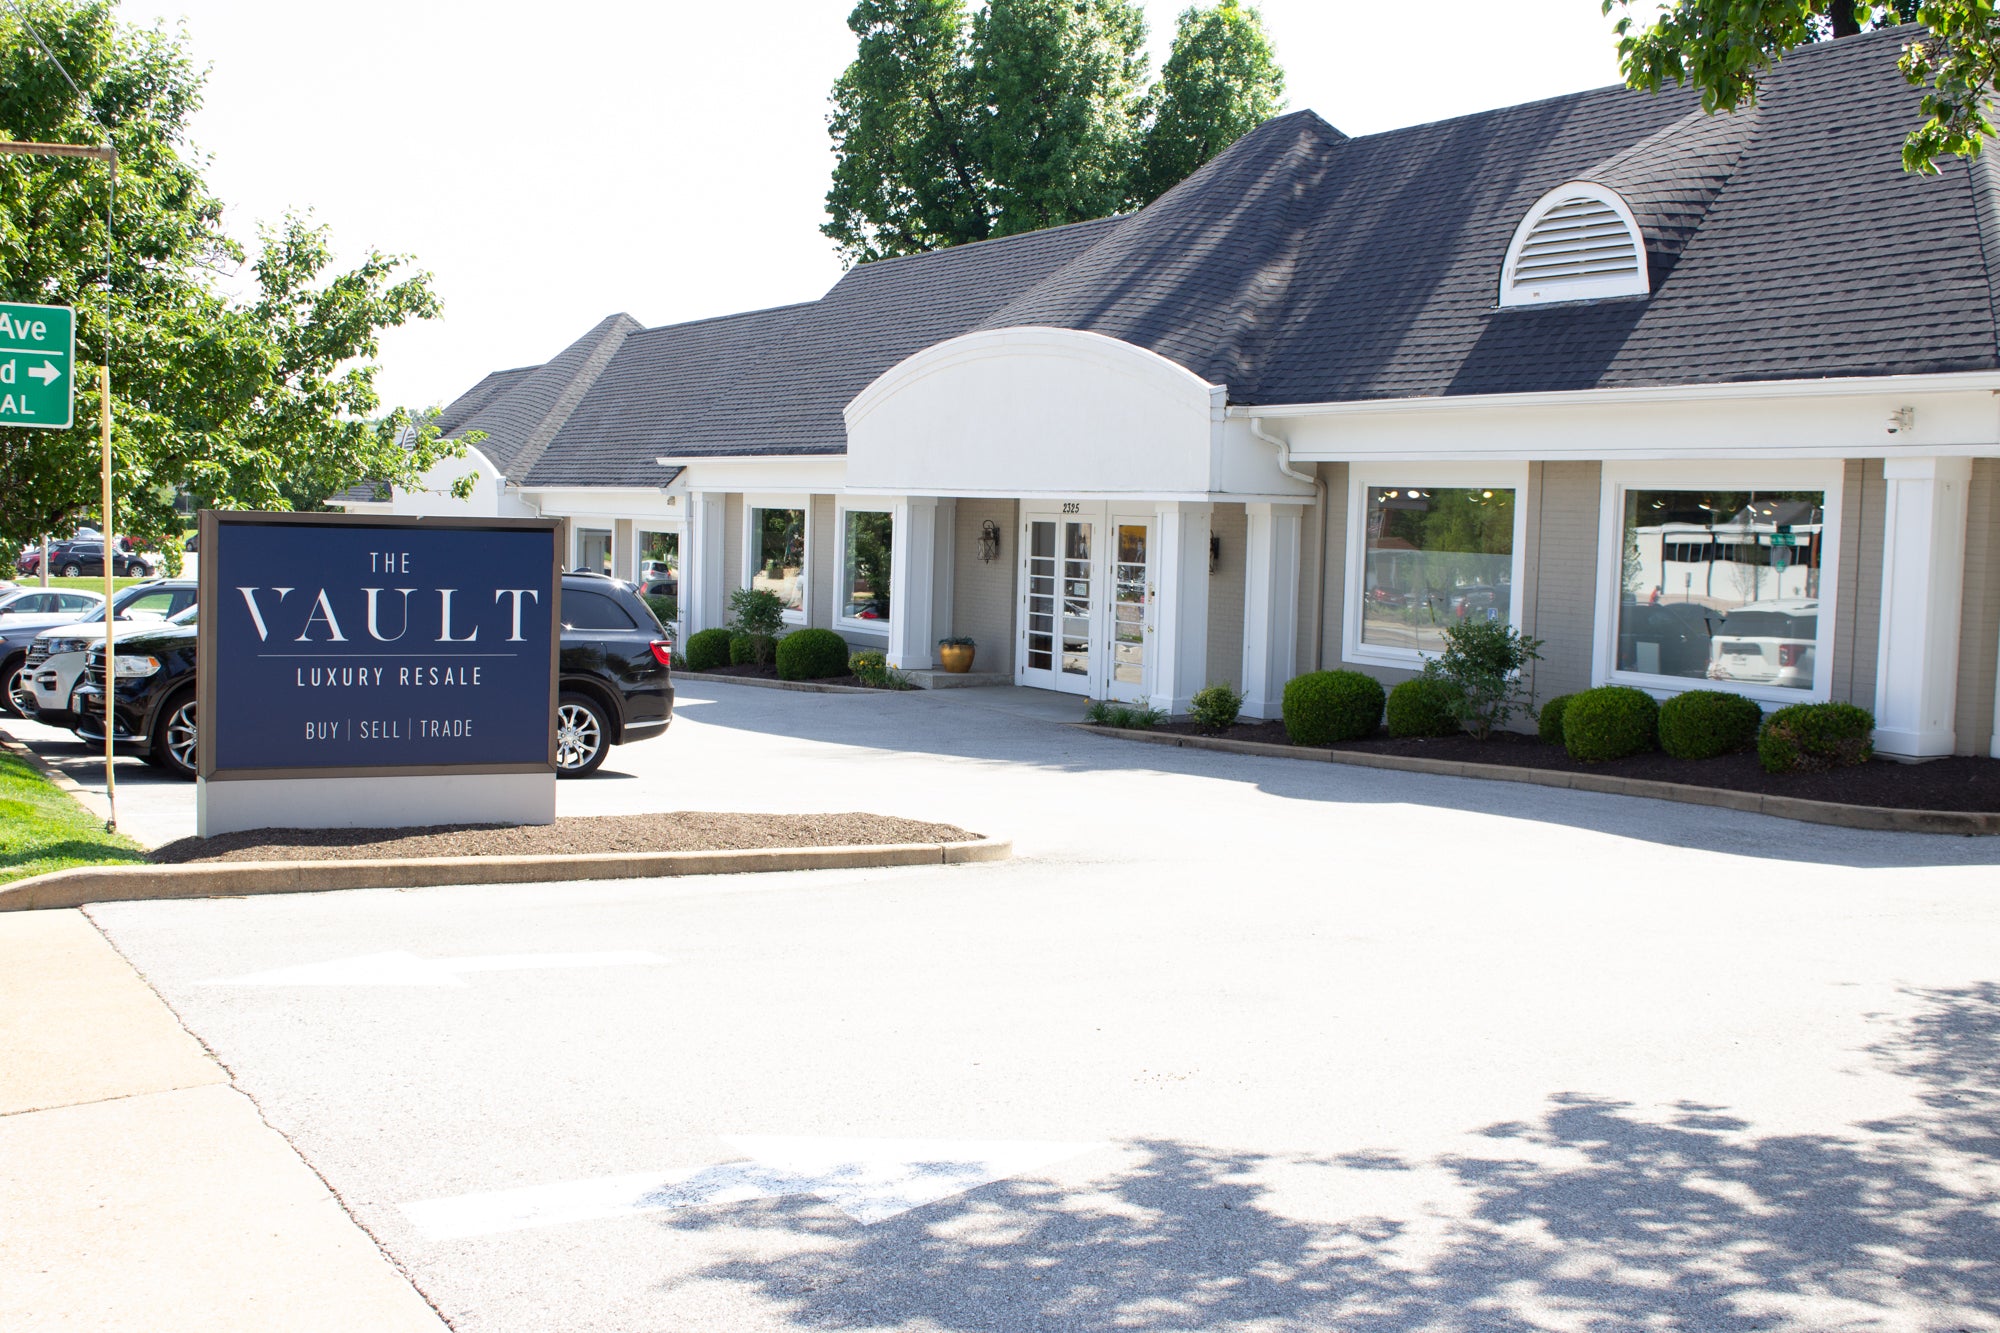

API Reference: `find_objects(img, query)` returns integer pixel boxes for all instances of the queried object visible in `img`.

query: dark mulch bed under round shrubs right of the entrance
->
[1120,719,2000,815]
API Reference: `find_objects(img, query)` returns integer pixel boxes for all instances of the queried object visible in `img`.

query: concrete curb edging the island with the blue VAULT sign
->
[0,839,1014,911]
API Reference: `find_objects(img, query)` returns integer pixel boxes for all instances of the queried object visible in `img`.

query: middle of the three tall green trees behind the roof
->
[970,0,1146,236]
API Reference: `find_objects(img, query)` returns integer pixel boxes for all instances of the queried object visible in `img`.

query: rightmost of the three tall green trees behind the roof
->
[1132,0,1284,204]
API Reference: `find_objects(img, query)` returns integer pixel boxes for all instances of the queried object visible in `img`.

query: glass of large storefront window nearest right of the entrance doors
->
[1358,486,1516,652]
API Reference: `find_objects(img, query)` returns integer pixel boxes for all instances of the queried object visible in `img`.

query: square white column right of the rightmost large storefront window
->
[1876,458,1972,759]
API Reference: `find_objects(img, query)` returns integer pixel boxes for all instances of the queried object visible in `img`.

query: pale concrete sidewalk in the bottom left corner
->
[0,911,446,1333]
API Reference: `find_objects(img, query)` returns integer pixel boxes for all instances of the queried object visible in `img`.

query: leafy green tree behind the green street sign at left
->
[0,0,462,544]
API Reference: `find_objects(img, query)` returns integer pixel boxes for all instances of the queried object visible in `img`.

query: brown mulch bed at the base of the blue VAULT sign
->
[152,811,980,865]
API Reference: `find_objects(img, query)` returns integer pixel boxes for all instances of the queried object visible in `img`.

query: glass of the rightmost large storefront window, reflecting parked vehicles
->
[1616,490,1826,693]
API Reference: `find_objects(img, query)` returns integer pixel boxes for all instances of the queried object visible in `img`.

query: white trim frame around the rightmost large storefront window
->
[1590,458,1852,705]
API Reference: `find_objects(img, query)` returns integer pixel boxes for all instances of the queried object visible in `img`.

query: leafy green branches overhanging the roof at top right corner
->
[1602,0,2000,172]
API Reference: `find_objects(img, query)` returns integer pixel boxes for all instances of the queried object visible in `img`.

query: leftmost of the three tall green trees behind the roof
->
[820,0,992,262]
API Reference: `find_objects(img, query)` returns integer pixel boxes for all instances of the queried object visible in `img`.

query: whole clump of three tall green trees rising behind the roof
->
[820,0,1284,262]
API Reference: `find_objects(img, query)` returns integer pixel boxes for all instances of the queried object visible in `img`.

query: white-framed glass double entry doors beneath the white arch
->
[1016,504,1154,701]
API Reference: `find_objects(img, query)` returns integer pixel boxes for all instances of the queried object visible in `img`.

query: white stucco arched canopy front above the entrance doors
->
[846,328,1224,496]
